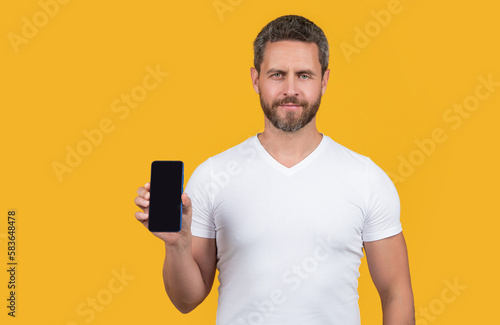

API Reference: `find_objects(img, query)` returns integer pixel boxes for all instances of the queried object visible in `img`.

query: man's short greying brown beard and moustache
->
[259,94,321,132]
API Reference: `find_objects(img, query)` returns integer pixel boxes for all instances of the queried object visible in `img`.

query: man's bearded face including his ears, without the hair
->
[251,41,329,132]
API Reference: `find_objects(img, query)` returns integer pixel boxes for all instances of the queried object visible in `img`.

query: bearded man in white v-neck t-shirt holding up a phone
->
[135,16,415,325]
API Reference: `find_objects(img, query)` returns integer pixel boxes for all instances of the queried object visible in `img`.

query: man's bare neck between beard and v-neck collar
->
[257,118,323,168]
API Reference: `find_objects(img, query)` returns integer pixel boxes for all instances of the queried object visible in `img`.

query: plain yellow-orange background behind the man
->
[0,0,500,325]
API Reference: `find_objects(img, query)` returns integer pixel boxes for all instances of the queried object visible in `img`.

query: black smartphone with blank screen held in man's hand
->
[148,160,184,232]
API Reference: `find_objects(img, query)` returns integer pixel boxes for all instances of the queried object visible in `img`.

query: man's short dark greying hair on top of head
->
[253,15,329,78]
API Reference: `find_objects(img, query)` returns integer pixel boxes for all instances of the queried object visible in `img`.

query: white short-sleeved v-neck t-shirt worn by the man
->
[186,135,402,325]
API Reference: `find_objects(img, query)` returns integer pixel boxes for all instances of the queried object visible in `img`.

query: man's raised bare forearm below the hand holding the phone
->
[163,245,208,313]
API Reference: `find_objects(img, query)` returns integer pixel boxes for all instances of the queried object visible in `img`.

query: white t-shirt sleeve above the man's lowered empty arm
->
[363,158,402,242]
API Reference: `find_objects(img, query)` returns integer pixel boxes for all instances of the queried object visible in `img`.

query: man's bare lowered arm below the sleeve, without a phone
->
[364,233,415,325]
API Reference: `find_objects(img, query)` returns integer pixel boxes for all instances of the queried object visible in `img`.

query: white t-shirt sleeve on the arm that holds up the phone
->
[185,158,215,238]
